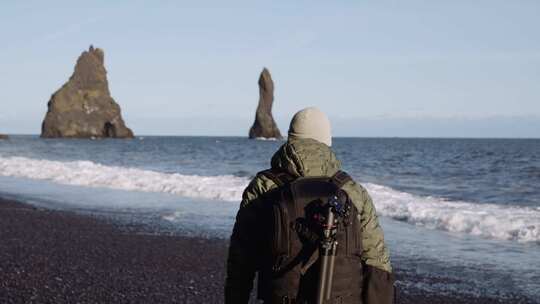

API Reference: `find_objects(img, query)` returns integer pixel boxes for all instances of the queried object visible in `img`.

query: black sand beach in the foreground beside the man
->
[0,199,535,304]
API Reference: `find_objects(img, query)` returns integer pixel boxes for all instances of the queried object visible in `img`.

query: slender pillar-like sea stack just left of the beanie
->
[249,68,283,139]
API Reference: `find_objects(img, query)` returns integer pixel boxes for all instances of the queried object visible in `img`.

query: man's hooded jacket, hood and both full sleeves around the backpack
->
[225,138,394,304]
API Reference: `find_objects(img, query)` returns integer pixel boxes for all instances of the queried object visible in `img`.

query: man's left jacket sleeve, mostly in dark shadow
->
[225,176,275,304]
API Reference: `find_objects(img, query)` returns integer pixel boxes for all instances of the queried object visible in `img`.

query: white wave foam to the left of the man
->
[0,157,249,201]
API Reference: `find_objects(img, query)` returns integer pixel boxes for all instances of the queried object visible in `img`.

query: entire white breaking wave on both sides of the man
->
[0,157,540,243]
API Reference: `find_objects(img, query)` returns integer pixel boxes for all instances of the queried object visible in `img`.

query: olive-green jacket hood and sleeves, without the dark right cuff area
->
[225,139,392,303]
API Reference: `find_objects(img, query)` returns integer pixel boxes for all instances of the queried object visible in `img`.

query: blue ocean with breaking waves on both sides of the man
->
[0,136,540,299]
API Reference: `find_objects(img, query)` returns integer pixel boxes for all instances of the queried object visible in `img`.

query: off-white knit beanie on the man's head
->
[289,107,332,147]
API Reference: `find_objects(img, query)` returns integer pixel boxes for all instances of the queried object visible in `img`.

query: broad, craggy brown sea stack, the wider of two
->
[41,46,133,138]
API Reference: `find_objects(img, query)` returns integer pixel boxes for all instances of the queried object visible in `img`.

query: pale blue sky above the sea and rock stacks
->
[0,0,540,137]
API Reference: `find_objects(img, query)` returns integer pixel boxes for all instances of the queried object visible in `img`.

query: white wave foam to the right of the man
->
[365,184,540,242]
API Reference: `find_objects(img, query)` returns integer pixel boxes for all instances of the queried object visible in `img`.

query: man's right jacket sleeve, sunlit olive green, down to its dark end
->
[344,183,395,304]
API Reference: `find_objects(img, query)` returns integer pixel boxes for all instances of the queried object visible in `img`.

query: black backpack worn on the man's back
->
[258,170,362,304]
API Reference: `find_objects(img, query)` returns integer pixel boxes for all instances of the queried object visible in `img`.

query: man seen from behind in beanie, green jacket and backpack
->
[225,108,394,304]
